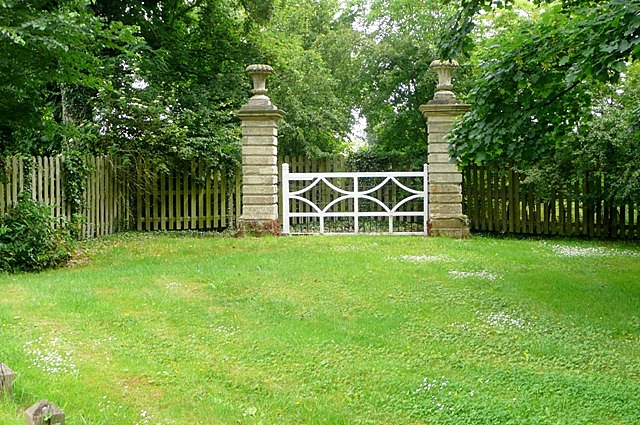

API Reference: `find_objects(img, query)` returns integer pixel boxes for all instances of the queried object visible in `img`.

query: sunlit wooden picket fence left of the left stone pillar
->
[0,156,241,238]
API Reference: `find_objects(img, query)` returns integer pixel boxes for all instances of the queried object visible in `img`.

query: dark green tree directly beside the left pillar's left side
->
[86,0,271,169]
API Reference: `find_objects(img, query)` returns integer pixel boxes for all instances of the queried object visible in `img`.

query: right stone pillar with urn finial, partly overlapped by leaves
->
[420,60,469,238]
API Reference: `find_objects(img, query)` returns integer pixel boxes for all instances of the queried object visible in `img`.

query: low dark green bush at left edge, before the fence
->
[0,194,72,273]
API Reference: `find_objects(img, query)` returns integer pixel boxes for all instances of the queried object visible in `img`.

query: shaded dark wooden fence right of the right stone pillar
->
[463,166,640,239]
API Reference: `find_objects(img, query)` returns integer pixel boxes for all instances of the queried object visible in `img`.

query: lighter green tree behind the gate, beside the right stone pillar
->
[356,0,465,169]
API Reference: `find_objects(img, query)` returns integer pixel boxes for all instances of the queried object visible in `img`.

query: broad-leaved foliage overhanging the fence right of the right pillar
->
[442,0,640,199]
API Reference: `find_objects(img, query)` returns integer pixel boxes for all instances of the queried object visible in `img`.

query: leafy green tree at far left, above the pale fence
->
[0,0,139,155]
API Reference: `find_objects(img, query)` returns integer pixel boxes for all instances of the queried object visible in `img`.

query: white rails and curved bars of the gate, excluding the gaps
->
[282,163,429,235]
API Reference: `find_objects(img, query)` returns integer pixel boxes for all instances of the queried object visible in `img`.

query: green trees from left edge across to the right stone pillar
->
[0,0,464,169]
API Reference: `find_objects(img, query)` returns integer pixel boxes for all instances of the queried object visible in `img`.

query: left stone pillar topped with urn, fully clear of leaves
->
[236,65,284,234]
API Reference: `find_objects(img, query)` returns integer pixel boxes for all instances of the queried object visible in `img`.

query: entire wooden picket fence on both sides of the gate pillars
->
[0,156,640,239]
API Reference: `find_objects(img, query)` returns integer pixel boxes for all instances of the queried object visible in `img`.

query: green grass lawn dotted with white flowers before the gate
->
[0,234,640,425]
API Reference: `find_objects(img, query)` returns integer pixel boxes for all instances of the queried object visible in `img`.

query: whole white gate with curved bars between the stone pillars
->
[281,163,429,235]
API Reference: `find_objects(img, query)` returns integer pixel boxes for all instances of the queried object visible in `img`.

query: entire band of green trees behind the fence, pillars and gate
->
[0,0,640,198]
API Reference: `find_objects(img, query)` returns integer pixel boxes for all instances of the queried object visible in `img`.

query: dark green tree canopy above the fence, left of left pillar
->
[0,0,272,171]
